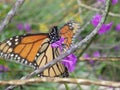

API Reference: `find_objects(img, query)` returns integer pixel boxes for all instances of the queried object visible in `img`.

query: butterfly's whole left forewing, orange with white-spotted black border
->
[0,34,49,65]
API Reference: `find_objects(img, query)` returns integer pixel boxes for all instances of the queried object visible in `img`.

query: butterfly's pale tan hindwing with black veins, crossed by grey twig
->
[36,41,68,77]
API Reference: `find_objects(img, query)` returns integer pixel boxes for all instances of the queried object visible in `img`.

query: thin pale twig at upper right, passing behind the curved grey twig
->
[78,3,120,17]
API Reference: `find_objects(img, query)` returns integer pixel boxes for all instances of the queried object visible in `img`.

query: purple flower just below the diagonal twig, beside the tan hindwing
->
[62,54,77,72]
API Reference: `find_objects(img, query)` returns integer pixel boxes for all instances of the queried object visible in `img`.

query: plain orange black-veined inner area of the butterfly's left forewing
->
[13,35,48,62]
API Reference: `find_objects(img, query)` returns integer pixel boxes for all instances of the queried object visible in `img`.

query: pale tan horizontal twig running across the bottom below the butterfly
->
[0,77,120,87]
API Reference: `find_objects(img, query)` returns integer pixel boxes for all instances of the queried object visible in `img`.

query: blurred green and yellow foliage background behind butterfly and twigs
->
[0,0,120,90]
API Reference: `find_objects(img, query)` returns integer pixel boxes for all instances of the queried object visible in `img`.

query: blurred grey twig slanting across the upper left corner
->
[0,0,25,32]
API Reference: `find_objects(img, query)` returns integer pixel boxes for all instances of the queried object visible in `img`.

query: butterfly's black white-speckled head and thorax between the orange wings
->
[49,26,60,43]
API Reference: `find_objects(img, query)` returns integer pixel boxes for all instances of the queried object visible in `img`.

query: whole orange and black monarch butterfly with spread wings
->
[0,22,78,77]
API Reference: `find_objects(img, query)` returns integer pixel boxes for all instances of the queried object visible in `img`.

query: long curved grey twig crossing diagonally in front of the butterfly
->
[6,0,110,90]
